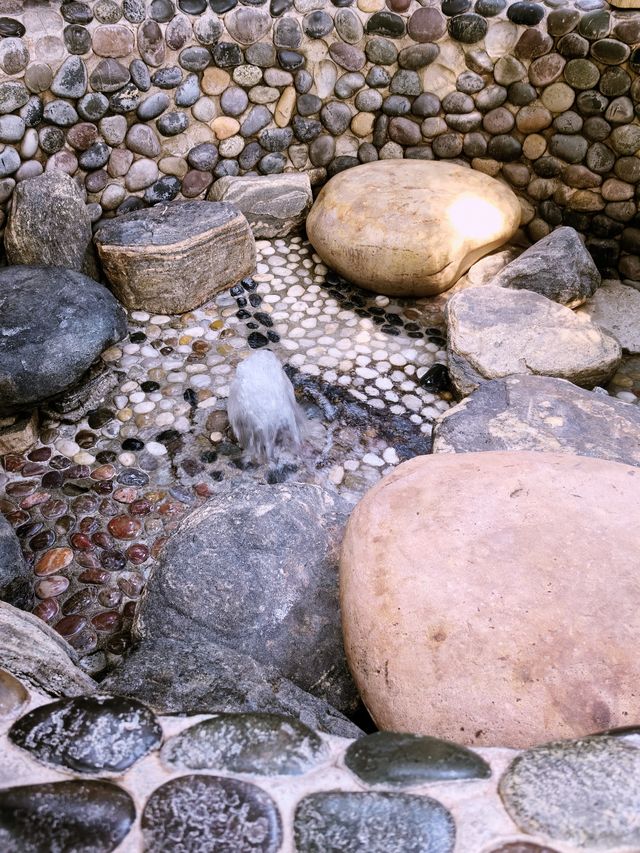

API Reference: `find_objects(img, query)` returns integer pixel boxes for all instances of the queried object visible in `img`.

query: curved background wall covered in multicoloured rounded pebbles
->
[0,0,640,281]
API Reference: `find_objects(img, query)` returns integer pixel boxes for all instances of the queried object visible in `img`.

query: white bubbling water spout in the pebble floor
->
[227,350,306,463]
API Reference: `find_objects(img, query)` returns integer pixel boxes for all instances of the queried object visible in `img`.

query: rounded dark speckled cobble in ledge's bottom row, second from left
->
[142,776,282,853]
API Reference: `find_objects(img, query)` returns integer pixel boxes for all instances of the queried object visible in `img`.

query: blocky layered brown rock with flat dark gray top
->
[94,201,256,314]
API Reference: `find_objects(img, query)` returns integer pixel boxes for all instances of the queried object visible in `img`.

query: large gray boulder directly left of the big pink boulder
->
[134,482,358,713]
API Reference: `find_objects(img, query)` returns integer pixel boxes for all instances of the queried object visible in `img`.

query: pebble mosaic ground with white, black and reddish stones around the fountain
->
[0,237,640,673]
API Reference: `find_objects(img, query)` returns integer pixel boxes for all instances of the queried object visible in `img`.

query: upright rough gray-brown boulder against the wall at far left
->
[4,171,95,275]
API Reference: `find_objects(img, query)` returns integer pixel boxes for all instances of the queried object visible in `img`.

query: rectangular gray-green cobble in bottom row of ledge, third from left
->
[294,791,455,853]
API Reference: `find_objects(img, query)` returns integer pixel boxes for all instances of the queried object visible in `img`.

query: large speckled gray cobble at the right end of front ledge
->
[499,737,640,849]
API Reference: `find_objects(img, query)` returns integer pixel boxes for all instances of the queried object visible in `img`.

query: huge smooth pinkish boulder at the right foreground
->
[341,452,640,747]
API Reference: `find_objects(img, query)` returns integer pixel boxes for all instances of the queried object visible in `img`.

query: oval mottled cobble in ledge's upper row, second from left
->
[161,713,329,776]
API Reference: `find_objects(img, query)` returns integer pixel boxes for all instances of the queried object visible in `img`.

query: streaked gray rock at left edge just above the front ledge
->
[0,602,96,697]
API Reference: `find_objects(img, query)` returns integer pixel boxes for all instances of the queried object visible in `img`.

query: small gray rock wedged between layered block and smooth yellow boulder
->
[208,172,313,238]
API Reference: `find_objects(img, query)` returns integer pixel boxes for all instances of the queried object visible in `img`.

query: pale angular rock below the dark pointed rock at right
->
[446,285,622,396]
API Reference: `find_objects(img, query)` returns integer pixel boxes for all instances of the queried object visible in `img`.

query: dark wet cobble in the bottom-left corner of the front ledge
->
[0,779,136,853]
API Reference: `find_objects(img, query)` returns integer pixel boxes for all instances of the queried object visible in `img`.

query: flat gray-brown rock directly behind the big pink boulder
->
[433,374,640,466]
